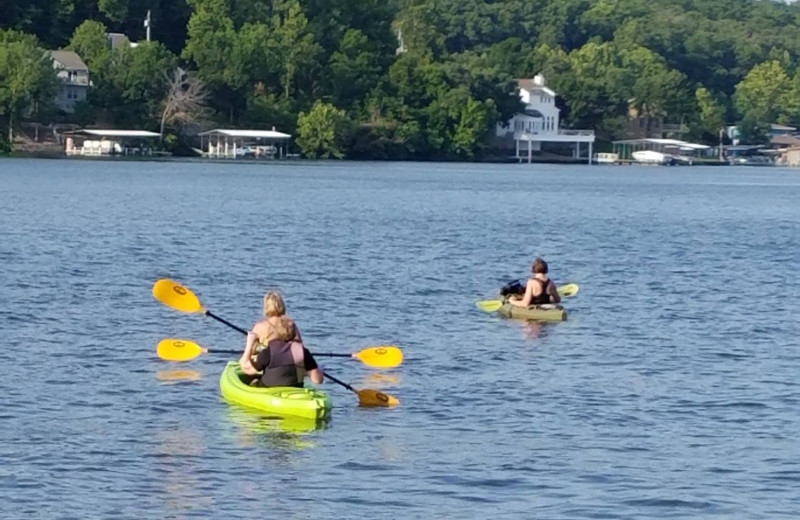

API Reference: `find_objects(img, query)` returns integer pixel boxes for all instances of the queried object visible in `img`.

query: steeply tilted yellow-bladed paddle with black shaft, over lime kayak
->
[153,278,400,406]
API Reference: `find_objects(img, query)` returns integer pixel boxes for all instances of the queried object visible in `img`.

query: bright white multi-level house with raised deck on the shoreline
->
[496,74,594,164]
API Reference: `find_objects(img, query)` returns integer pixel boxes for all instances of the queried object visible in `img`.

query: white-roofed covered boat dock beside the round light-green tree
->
[198,128,292,159]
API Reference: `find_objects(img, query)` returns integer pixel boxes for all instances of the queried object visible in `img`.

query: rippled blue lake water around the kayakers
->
[0,159,800,519]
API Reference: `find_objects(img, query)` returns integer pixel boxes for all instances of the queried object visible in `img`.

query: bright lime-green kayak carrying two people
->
[219,361,331,420]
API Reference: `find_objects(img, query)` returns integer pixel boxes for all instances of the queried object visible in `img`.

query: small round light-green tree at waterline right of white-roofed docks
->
[297,101,350,159]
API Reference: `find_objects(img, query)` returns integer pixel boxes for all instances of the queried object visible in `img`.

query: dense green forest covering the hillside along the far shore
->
[0,0,800,159]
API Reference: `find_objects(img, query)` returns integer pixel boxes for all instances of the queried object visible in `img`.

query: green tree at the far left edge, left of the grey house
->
[0,31,59,144]
